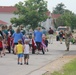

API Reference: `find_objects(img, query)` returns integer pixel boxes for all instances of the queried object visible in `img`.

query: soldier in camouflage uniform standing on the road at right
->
[65,27,71,51]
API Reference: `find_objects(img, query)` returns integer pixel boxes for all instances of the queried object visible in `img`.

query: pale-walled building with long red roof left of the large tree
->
[0,6,18,25]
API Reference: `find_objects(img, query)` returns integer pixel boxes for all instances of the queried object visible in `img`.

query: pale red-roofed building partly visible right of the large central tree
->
[41,11,61,30]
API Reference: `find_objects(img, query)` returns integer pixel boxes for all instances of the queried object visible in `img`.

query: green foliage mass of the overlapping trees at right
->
[53,3,76,29]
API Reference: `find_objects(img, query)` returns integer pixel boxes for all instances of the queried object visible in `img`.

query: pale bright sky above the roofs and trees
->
[0,0,76,14]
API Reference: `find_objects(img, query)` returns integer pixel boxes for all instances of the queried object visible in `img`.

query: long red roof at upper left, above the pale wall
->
[0,6,17,13]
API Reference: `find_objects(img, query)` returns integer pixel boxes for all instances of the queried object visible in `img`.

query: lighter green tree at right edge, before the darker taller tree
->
[56,10,76,29]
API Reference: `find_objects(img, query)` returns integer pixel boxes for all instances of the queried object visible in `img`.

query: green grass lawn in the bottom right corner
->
[51,59,76,75]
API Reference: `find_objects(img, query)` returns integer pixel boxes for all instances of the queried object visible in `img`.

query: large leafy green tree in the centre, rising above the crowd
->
[11,0,48,29]
